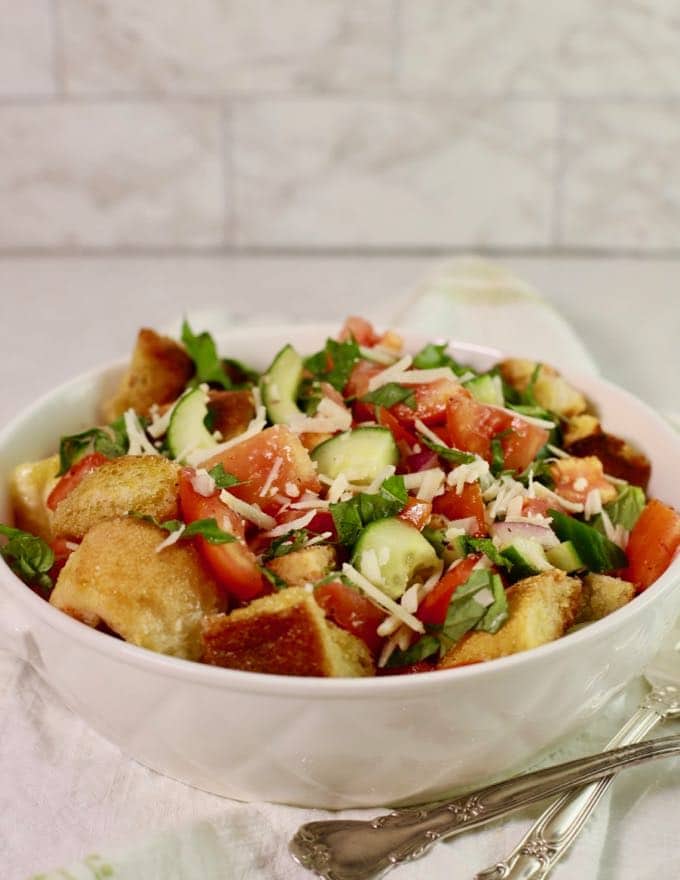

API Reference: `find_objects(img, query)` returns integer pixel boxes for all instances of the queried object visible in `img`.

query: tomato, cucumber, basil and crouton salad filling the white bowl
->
[0,318,680,678]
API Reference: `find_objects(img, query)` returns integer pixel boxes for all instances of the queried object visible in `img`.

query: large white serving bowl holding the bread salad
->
[0,326,680,808]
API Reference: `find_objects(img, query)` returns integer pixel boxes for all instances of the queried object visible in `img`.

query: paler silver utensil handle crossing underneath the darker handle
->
[475,686,680,880]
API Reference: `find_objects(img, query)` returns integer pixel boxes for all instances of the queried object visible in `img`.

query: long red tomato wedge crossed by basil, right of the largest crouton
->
[179,468,269,602]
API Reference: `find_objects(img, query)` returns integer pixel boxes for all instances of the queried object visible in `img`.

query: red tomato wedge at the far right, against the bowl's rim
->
[626,499,680,590]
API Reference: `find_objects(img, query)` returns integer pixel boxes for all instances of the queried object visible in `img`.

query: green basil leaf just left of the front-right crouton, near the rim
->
[387,569,508,666]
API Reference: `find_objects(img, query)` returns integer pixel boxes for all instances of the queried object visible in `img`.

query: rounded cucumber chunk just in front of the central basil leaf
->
[352,518,441,599]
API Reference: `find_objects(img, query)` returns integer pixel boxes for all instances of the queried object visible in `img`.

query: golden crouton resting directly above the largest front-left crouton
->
[52,455,179,538]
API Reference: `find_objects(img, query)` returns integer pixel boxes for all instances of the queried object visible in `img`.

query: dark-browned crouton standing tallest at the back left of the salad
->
[102,328,194,422]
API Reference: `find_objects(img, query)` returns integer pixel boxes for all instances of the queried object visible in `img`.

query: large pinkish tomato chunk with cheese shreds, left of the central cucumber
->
[204,425,321,514]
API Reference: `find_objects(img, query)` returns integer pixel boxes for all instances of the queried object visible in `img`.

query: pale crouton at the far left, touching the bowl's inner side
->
[9,455,59,541]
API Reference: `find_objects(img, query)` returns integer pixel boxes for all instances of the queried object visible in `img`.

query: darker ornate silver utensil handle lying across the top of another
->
[290,724,680,880]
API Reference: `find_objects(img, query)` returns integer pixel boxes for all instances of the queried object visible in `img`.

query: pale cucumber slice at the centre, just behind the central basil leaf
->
[311,427,399,485]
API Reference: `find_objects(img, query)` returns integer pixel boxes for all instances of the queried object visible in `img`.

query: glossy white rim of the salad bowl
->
[0,323,680,700]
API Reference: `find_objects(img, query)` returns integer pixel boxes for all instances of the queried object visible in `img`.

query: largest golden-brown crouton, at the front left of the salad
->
[50,517,224,660]
